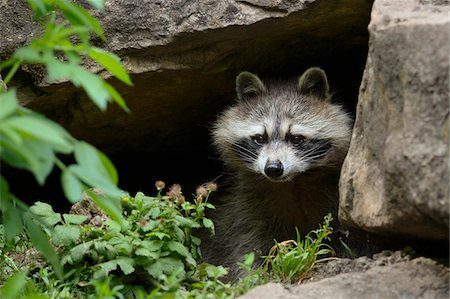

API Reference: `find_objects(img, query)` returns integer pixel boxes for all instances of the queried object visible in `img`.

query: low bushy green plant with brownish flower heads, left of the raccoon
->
[0,182,216,298]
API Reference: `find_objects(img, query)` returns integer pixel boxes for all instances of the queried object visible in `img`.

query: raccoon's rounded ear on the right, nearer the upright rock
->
[297,67,329,99]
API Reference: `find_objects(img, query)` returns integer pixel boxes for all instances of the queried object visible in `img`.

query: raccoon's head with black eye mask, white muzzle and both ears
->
[213,68,350,182]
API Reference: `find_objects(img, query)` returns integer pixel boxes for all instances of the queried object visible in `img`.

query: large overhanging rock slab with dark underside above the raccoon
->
[0,0,372,154]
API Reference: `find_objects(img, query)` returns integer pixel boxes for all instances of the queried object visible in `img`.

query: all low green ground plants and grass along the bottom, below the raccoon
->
[0,193,332,299]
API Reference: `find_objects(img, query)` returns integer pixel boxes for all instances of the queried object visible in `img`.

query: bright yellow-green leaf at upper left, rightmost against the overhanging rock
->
[88,47,133,85]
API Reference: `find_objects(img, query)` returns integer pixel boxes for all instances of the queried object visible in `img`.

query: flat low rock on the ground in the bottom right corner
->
[239,252,450,299]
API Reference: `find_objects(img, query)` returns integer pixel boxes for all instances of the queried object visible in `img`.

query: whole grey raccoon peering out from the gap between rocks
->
[202,68,352,278]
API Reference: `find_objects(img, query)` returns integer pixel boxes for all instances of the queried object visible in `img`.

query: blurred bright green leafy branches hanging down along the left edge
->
[0,0,131,277]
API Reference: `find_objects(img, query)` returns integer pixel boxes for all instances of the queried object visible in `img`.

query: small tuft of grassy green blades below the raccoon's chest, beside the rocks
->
[264,214,334,283]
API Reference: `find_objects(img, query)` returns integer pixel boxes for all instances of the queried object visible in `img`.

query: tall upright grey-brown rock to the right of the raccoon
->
[339,0,450,244]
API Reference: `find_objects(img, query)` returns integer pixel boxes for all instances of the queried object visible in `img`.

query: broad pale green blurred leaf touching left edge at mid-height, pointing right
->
[2,114,72,154]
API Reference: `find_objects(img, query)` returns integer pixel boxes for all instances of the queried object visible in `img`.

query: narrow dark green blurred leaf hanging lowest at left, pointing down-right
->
[24,212,63,279]
